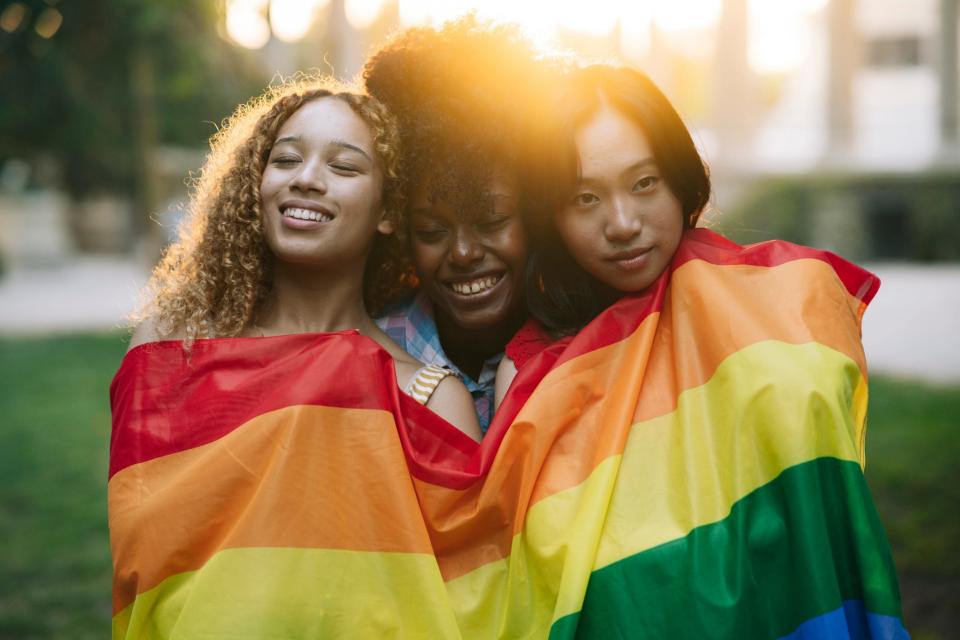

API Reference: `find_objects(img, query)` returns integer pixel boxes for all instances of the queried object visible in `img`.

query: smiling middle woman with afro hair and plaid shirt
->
[363,16,553,431]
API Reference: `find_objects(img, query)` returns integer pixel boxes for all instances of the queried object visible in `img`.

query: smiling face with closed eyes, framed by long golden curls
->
[260,97,392,273]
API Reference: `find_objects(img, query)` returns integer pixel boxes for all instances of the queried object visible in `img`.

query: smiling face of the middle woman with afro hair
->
[410,170,527,330]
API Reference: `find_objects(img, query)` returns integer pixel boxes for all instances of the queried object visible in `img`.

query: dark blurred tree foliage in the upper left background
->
[0,0,262,249]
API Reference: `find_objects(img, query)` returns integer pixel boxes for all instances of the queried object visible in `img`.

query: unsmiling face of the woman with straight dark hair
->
[555,105,683,293]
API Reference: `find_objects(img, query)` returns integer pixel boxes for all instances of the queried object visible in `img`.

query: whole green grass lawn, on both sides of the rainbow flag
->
[0,334,960,640]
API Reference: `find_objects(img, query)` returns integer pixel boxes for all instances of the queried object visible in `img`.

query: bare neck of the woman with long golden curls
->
[256,263,373,335]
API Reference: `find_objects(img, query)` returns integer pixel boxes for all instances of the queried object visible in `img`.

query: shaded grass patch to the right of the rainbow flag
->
[867,376,960,640]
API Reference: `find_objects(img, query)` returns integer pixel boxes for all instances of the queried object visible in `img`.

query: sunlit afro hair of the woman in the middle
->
[363,15,559,222]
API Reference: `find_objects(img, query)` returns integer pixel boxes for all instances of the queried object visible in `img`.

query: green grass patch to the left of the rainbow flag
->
[0,334,126,640]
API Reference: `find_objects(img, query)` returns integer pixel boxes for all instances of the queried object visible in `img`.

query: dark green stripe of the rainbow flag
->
[550,458,901,640]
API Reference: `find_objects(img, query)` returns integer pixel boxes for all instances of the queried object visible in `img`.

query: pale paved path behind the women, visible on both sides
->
[0,257,960,383]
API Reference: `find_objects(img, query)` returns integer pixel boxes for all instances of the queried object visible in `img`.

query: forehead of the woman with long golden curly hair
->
[277,97,373,151]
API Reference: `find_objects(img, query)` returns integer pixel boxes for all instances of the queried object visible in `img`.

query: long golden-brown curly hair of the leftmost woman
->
[134,76,412,346]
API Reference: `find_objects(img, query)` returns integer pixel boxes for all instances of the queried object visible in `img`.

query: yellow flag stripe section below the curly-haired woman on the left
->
[113,548,459,640]
